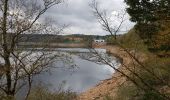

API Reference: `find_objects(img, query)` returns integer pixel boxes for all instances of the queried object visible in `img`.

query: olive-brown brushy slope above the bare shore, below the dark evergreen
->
[106,29,170,100]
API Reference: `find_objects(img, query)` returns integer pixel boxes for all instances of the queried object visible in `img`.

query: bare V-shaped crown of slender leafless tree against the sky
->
[90,0,127,40]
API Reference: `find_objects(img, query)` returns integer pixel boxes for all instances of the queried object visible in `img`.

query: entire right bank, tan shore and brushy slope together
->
[79,27,170,100]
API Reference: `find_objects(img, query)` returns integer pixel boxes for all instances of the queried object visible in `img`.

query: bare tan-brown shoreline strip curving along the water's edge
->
[78,46,145,100]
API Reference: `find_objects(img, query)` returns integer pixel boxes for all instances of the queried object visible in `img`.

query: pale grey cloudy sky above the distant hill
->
[45,0,134,35]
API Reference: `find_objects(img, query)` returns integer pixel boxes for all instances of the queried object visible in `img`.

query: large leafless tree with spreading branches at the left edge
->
[0,0,68,99]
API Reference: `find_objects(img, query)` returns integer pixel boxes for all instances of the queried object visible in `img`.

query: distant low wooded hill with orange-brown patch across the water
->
[0,33,106,44]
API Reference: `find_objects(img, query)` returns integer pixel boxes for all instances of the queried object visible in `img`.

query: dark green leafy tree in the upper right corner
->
[124,0,170,48]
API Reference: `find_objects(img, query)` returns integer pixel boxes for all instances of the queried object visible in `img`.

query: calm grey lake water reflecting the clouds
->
[16,48,118,98]
